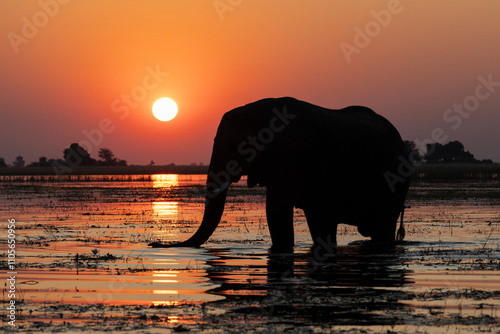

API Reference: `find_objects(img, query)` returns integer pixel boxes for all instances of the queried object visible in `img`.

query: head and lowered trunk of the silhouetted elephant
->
[146,99,296,247]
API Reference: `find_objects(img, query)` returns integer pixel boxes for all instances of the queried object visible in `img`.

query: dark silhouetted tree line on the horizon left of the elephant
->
[0,143,127,167]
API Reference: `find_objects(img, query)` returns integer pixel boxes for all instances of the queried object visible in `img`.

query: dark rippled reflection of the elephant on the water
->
[206,242,413,325]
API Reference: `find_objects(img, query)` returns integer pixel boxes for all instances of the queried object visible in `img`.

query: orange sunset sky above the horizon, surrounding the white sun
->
[0,0,500,165]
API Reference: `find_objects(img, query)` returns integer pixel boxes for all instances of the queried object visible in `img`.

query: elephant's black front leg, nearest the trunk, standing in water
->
[266,186,294,252]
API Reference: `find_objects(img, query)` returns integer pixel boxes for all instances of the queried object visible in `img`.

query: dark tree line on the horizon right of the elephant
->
[405,140,493,164]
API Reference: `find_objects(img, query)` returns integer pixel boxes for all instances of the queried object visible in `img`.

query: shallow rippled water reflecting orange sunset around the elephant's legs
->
[0,175,500,332]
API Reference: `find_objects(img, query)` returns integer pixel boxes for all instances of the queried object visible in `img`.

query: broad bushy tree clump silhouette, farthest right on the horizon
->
[425,141,479,163]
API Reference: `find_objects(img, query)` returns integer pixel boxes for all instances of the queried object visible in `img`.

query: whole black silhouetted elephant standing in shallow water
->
[150,97,411,252]
